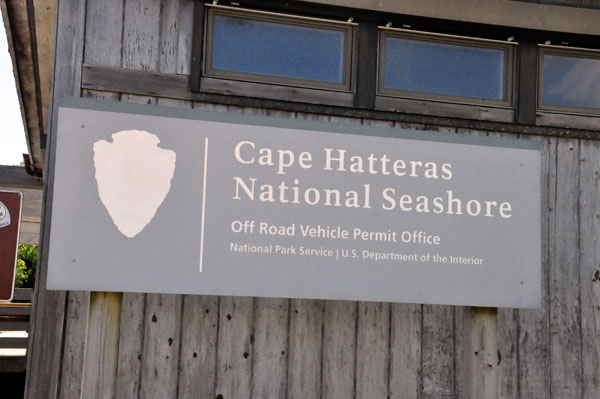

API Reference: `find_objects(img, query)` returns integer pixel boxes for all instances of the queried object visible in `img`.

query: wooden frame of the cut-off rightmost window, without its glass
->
[537,44,600,117]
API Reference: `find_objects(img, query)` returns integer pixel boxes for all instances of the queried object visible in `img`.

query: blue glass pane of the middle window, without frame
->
[384,36,506,100]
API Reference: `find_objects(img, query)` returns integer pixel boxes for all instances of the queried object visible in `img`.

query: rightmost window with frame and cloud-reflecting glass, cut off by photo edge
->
[538,45,600,114]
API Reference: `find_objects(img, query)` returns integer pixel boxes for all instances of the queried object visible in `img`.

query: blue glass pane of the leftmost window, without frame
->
[212,15,344,83]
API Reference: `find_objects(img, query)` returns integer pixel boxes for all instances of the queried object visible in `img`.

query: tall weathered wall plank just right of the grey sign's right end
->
[550,140,582,398]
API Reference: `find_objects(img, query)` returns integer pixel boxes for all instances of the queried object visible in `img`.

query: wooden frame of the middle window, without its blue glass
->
[377,26,519,110]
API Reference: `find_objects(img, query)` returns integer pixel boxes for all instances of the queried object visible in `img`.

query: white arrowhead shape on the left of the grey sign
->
[94,130,176,238]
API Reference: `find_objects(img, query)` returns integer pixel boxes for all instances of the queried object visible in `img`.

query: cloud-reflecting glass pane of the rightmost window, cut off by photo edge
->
[543,54,600,108]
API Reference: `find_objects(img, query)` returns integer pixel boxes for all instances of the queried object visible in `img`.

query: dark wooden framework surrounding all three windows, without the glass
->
[188,0,600,137]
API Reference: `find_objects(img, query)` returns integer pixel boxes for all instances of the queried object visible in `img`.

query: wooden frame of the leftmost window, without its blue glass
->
[202,4,358,97]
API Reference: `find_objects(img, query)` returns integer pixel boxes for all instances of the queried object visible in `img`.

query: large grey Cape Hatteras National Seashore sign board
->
[47,99,541,307]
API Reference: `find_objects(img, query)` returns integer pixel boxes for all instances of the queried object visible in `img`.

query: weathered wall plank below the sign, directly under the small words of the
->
[421,305,454,399]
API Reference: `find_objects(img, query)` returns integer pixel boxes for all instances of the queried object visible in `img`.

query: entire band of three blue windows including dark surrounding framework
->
[190,1,600,130]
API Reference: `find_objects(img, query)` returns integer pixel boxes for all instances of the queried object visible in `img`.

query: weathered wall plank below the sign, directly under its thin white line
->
[179,295,219,399]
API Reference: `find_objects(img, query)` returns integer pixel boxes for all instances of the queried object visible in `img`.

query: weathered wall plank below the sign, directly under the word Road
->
[251,298,290,399]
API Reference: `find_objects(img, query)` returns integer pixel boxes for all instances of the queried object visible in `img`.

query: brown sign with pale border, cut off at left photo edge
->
[0,190,23,301]
